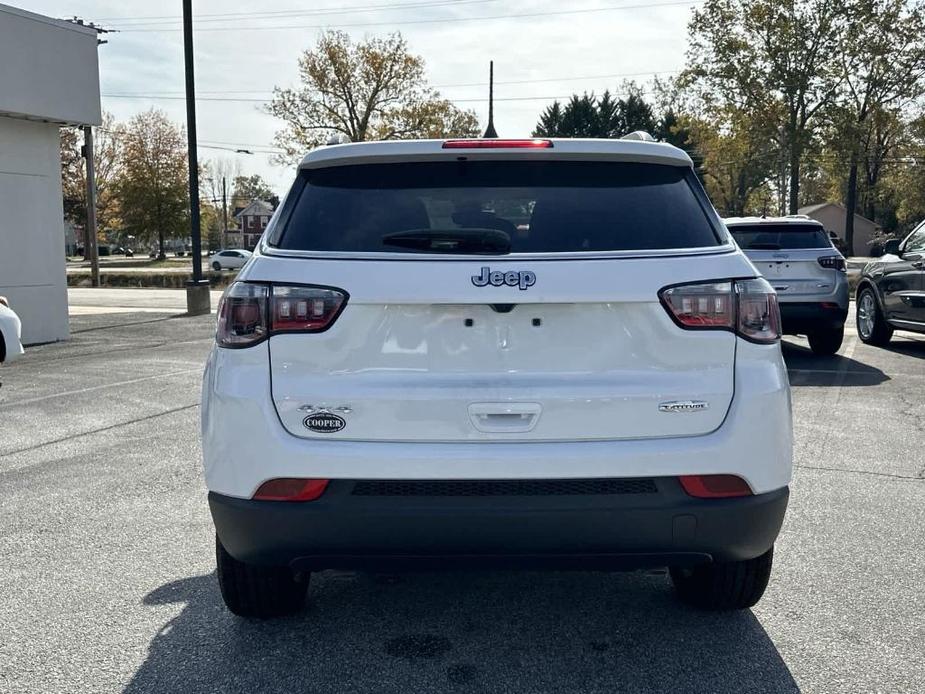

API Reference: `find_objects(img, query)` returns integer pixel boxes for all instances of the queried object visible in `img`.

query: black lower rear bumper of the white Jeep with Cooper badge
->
[209,477,789,570]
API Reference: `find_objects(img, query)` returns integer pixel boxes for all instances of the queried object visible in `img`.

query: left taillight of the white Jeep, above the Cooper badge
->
[215,282,347,348]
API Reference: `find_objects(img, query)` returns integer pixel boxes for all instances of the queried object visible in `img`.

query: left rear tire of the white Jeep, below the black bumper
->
[215,536,309,619]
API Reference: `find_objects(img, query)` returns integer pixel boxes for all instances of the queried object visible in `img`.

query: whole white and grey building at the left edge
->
[0,4,100,344]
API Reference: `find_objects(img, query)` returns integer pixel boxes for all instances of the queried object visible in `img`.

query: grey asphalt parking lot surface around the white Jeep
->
[0,294,925,693]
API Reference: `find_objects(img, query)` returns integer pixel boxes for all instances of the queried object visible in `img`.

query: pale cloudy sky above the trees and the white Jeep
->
[23,0,698,192]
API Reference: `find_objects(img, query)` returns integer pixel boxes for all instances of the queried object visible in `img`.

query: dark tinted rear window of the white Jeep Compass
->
[270,161,722,254]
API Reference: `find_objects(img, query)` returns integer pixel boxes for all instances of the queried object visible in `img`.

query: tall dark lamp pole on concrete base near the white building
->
[183,0,212,315]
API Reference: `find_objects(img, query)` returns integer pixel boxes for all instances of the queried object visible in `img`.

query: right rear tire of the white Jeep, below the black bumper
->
[670,547,774,610]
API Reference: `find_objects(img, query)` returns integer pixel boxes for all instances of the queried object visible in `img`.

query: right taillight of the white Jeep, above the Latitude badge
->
[659,278,780,343]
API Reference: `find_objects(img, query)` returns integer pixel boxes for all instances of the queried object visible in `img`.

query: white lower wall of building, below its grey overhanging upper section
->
[0,118,68,344]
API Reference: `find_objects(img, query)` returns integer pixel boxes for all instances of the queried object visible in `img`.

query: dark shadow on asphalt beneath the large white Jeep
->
[125,572,799,694]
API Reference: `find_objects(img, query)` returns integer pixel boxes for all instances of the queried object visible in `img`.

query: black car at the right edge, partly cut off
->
[856,222,925,345]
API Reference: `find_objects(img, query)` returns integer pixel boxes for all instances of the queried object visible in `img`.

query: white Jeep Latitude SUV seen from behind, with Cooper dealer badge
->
[202,140,792,617]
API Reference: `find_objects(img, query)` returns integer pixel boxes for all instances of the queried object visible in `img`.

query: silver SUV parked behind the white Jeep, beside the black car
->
[724,215,848,354]
